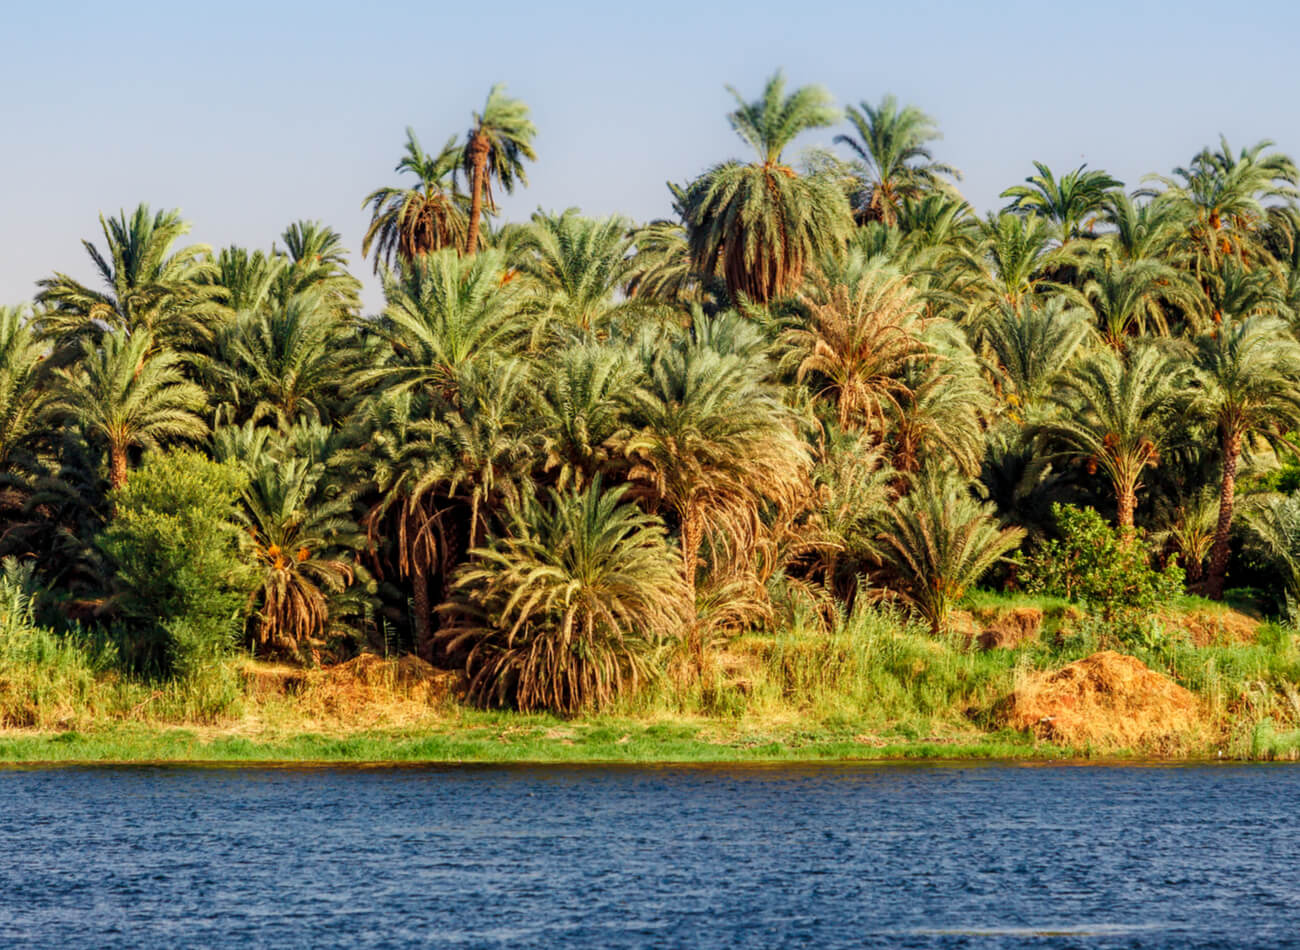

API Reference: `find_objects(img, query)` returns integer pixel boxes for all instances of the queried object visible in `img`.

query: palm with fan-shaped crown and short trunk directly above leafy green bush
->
[1037,344,1192,534]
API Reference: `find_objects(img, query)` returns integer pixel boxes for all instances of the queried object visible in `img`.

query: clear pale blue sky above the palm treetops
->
[0,0,1300,309]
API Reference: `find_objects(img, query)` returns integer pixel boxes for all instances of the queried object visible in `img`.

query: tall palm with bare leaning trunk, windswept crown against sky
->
[462,84,537,255]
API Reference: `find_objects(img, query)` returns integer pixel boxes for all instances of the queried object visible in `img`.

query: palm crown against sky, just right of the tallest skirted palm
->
[835,95,962,226]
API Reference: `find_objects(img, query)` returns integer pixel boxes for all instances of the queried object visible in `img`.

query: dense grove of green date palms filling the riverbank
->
[0,75,1300,712]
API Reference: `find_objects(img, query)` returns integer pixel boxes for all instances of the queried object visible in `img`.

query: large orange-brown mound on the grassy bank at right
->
[996,650,1203,750]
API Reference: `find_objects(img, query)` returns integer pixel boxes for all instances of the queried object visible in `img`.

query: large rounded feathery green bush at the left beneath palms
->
[99,451,252,676]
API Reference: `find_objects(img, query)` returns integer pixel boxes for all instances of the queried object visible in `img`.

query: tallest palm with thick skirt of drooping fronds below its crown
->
[683,73,852,304]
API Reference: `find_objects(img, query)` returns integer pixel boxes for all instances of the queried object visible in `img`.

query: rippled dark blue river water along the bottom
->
[0,765,1300,949]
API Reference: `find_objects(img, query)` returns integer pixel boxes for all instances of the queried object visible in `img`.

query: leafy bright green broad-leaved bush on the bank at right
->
[1021,504,1183,620]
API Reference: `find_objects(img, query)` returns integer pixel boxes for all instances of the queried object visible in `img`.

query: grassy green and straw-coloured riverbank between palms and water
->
[0,594,1300,763]
